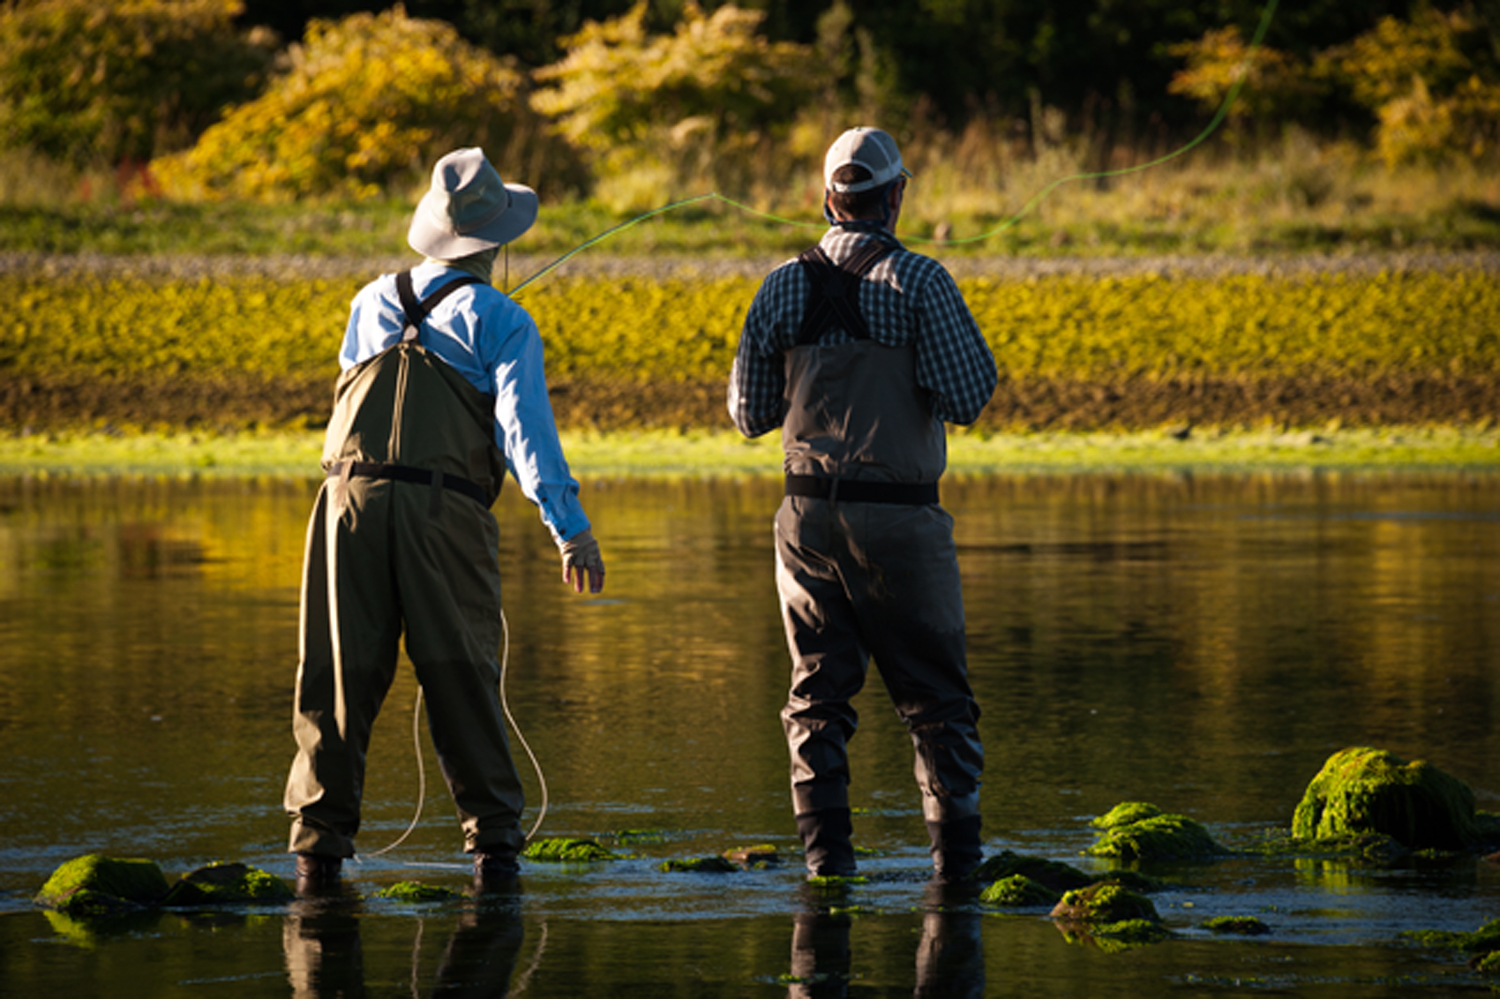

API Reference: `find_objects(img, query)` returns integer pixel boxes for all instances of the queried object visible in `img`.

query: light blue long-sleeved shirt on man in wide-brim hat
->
[339,256,588,540]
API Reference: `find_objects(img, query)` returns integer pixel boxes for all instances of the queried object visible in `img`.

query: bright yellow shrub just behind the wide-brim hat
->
[152,5,567,201]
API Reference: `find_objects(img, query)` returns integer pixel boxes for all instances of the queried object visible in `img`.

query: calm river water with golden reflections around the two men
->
[0,474,1500,998]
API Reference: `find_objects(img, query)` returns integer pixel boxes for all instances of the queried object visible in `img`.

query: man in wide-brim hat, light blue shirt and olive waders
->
[287,149,605,887]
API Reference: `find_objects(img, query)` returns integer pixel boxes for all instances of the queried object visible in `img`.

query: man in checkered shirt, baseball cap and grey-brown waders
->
[729,129,996,878]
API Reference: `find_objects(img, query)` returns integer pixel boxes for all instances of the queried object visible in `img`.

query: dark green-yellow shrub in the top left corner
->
[0,0,276,165]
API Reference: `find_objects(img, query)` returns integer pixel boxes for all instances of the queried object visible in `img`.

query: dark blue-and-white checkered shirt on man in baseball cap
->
[729,227,996,437]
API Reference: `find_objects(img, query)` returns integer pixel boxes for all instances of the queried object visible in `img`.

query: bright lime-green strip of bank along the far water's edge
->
[0,428,1500,482]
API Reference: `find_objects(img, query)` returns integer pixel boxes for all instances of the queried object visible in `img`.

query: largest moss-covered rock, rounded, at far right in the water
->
[1292,747,1487,851]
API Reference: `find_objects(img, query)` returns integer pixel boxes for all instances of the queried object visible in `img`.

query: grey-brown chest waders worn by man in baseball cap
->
[776,242,984,876]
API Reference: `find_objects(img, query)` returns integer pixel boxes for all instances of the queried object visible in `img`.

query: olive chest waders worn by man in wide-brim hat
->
[285,273,525,857]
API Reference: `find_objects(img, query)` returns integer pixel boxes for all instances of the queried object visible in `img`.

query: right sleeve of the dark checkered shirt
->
[917,266,999,425]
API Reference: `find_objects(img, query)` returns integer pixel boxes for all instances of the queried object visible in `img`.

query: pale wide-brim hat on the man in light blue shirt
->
[407,149,539,260]
